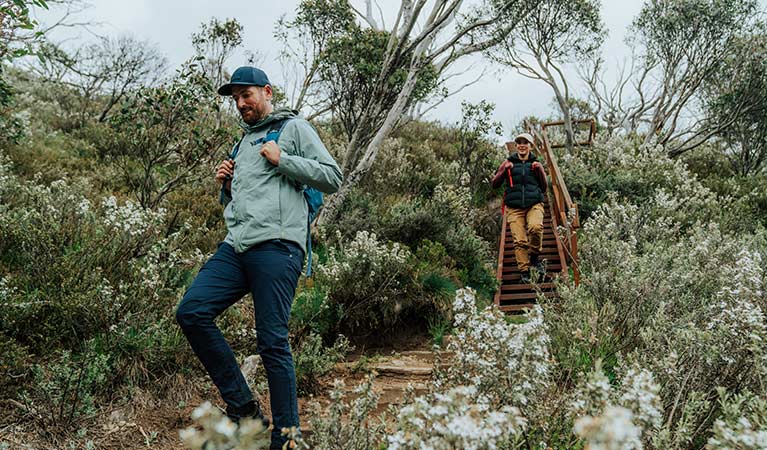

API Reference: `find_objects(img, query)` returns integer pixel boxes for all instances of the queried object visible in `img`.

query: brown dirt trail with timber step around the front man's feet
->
[0,340,444,450]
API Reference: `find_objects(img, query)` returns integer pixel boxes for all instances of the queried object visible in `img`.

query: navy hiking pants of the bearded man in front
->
[176,240,304,441]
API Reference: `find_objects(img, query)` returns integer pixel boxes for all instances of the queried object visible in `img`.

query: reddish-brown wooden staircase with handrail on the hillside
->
[495,120,596,314]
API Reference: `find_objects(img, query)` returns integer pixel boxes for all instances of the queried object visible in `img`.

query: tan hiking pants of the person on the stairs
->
[506,202,543,272]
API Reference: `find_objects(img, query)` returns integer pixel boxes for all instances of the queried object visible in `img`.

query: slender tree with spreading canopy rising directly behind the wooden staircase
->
[486,0,606,149]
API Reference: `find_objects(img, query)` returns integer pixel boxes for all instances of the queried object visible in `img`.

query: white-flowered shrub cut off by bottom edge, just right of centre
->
[387,386,526,450]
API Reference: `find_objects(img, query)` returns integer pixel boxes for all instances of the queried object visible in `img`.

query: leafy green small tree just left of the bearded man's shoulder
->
[100,64,231,208]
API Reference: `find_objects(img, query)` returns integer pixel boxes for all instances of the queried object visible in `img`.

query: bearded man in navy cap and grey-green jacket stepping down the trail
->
[176,67,342,448]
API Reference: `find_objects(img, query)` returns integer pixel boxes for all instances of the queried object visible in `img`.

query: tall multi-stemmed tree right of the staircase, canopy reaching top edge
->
[632,0,757,155]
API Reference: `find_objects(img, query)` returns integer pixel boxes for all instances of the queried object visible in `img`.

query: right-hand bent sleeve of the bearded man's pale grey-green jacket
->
[277,119,343,194]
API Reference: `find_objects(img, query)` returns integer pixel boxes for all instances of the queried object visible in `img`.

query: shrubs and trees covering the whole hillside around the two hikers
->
[0,0,767,450]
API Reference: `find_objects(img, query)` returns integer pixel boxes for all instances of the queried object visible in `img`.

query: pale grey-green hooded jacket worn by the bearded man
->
[224,108,343,253]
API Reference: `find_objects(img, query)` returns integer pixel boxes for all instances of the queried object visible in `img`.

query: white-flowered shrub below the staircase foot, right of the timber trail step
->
[437,289,551,412]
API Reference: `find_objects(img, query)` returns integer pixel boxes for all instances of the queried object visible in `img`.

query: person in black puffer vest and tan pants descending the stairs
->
[492,133,546,284]
